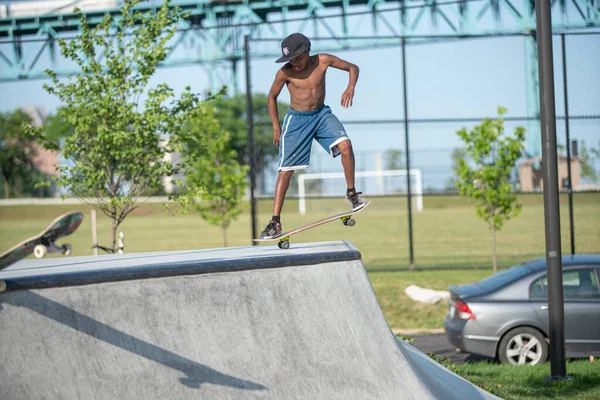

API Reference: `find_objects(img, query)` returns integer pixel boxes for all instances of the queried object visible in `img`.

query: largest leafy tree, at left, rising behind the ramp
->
[27,0,205,250]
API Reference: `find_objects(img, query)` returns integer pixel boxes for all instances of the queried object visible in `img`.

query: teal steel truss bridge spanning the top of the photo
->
[0,0,600,81]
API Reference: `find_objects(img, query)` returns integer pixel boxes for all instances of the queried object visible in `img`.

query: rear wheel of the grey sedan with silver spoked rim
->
[498,327,548,365]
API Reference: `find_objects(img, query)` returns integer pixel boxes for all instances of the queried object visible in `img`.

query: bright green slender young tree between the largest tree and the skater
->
[175,106,248,247]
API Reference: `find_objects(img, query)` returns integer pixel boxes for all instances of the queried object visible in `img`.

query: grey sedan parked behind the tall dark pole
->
[444,255,600,364]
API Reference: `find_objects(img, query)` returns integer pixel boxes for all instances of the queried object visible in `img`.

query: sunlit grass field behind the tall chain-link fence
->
[0,193,600,270]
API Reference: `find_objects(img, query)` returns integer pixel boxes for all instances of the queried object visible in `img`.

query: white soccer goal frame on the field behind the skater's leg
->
[298,169,423,215]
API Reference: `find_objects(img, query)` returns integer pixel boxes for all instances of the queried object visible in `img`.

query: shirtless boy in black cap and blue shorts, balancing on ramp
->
[260,33,364,239]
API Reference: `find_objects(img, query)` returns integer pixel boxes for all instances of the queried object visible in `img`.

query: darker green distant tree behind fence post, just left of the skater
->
[212,94,289,191]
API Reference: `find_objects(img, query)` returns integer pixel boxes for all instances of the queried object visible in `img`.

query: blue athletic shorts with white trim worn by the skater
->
[278,105,350,171]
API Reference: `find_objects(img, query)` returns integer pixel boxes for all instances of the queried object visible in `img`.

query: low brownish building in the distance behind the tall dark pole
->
[518,155,581,192]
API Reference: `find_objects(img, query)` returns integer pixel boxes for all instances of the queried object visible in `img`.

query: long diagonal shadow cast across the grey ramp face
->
[0,291,267,390]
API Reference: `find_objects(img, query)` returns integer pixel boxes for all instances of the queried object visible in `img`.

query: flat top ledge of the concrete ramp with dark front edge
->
[0,241,361,291]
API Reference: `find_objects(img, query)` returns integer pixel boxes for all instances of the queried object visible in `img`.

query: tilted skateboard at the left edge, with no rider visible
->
[0,212,83,270]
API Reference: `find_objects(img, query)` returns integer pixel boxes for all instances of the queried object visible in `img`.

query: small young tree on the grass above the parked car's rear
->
[454,107,525,273]
